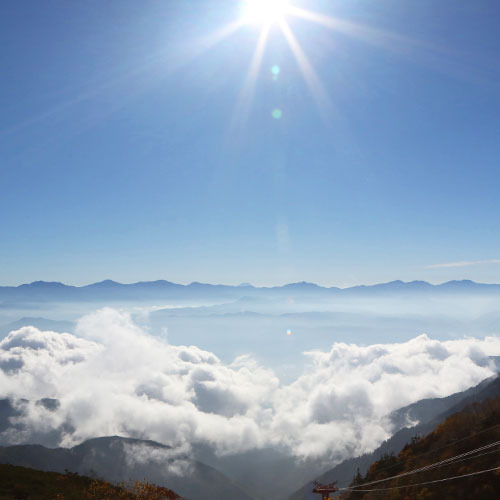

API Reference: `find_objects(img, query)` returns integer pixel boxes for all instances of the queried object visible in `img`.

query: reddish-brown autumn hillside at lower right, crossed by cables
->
[341,397,500,500]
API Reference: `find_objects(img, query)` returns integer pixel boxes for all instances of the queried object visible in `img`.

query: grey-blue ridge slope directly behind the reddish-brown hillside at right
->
[288,376,500,500]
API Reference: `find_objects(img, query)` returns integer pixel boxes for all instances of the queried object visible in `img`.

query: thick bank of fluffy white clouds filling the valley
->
[0,308,500,458]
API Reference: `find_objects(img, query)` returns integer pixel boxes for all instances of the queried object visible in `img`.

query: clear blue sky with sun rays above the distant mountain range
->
[0,0,500,286]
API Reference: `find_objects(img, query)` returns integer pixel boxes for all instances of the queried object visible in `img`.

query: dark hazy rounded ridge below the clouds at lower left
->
[0,436,254,500]
